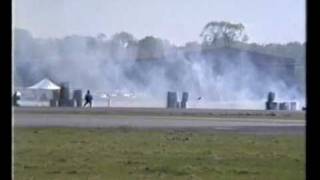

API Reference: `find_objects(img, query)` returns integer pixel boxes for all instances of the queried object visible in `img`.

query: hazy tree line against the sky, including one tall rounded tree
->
[14,21,305,90]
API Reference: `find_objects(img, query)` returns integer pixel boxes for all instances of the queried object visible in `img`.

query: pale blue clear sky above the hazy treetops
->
[12,0,306,45]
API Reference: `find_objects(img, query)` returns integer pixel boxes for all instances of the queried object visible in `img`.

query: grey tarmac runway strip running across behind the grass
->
[13,107,306,134]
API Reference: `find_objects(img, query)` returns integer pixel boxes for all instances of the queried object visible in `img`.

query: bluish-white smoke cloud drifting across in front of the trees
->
[14,29,304,108]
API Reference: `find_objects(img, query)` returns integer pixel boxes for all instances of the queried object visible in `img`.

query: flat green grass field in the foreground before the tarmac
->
[14,128,305,180]
